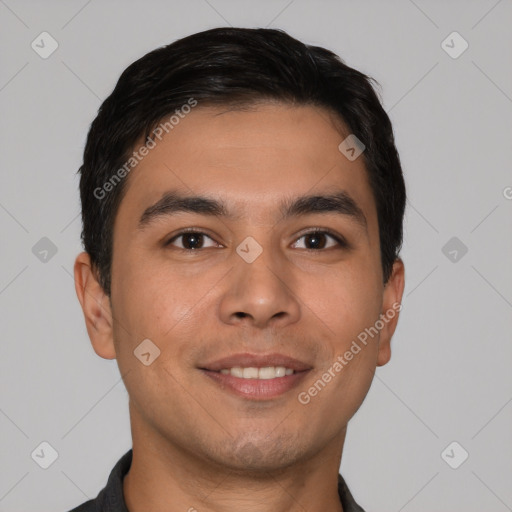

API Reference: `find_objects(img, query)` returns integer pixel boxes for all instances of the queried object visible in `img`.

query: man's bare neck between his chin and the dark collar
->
[123,404,346,512]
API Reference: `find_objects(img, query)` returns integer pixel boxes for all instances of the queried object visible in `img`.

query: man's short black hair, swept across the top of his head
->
[78,28,406,296]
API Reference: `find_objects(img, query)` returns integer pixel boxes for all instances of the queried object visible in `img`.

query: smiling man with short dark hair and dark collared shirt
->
[71,28,405,512]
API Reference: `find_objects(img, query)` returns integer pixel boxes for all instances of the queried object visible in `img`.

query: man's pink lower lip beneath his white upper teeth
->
[201,368,309,400]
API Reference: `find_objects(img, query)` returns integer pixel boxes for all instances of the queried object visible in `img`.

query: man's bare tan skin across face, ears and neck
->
[75,103,404,512]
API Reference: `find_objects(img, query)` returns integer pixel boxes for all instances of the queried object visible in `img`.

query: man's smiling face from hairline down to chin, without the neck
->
[85,104,401,469]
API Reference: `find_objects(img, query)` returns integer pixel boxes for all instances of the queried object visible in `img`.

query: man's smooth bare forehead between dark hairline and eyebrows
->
[117,104,374,227]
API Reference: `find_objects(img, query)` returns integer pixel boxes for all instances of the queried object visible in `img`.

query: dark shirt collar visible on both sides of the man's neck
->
[69,449,364,512]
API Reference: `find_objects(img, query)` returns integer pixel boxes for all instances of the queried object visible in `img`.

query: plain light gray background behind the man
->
[0,0,512,512]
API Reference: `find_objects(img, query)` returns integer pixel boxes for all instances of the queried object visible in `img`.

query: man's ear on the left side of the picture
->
[74,252,116,359]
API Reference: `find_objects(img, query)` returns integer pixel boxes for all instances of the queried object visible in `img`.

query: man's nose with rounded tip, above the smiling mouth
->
[219,245,301,329]
